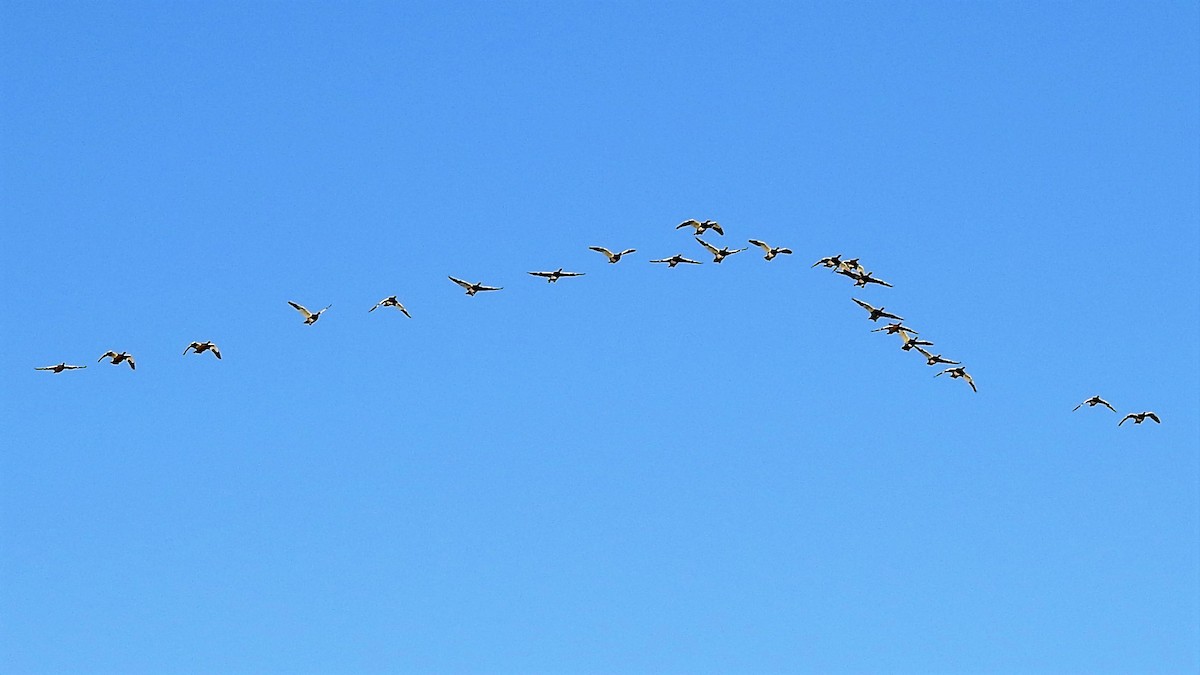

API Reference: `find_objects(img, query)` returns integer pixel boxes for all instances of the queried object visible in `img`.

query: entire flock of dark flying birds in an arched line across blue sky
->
[34,220,1162,426]
